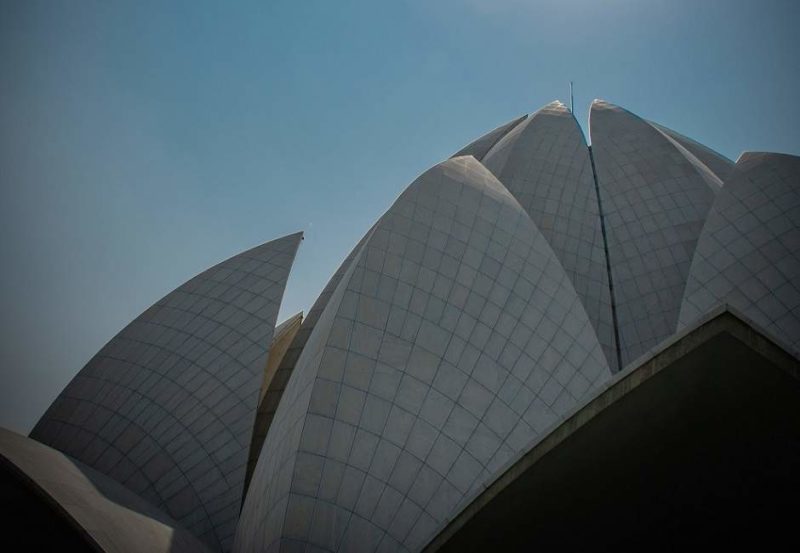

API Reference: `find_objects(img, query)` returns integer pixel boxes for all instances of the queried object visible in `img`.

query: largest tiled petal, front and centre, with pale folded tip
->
[235,156,610,551]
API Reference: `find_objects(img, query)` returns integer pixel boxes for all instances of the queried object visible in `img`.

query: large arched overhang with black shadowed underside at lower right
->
[426,306,800,551]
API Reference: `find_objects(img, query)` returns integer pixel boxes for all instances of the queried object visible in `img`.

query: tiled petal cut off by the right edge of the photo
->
[679,152,800,354]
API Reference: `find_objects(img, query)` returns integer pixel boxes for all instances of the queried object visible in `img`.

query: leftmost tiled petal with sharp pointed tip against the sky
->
[31,233,302,551]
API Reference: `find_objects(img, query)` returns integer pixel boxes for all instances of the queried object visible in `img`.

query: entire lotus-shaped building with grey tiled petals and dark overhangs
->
[0,100,800,553]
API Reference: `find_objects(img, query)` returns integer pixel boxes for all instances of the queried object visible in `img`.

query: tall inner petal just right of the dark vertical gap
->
[590,100,718,366]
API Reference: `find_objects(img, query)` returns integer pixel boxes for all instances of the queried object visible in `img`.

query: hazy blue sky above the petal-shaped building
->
[0,0,800,432]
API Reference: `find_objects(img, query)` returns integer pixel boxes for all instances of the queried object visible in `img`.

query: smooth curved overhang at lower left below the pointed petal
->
[0,428,209,553]
